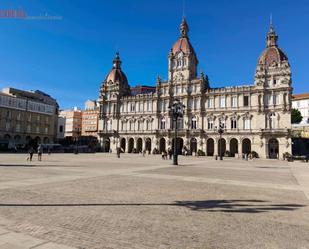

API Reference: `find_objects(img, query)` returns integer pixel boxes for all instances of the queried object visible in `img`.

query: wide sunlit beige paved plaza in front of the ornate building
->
[0,154,309,249]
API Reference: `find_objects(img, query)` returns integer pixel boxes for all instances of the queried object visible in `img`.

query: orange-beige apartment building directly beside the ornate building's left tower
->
[82,100,99,137]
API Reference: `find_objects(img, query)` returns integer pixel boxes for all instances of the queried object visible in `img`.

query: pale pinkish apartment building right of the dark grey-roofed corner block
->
[59,107,82,138]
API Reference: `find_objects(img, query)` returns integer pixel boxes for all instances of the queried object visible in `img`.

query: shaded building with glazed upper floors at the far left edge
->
[0,88,59,150]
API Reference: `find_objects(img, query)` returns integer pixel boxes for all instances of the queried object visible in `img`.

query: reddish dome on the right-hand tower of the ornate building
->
[258,46,288,66]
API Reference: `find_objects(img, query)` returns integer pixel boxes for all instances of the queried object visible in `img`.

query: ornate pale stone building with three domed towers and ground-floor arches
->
[99,18,292,158]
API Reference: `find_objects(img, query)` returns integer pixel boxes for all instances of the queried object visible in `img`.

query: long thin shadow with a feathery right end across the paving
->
[0,200,306,213]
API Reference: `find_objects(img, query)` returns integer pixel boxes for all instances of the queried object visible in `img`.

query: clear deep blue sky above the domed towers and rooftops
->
[0,0,309,108]
